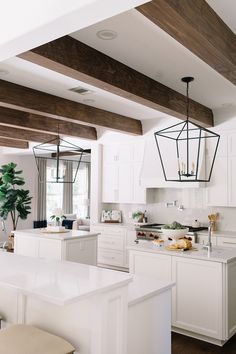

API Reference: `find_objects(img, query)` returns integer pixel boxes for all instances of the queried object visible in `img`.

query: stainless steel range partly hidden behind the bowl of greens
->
[135,224,208,242]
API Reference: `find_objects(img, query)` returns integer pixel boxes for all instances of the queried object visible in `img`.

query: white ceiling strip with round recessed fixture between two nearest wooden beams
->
[72,10,236,108]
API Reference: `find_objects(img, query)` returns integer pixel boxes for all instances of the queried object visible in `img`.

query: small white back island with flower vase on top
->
[14,229,98,265]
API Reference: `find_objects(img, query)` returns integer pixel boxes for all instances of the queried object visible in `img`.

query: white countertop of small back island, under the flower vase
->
[14,229,98,240]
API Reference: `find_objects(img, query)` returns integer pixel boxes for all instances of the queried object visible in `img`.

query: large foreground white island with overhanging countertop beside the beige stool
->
[0,252,173,354]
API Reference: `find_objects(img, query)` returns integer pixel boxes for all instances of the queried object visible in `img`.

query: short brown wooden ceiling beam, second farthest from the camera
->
[0,125,57,143]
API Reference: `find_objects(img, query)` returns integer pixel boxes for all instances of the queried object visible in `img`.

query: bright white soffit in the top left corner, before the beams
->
[0,0,148,60]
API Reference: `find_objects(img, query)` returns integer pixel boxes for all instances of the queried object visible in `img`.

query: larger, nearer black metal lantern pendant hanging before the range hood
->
[154,77,220,182]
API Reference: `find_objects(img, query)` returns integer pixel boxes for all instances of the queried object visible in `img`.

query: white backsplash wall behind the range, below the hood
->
[103,188,236,231]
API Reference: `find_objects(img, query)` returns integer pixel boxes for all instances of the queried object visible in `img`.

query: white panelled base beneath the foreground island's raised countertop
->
[0,285,128,354]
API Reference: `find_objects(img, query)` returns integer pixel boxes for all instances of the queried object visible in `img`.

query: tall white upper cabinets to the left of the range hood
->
[102,140,146,204]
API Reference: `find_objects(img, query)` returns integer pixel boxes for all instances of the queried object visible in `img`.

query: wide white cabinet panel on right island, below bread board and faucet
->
[172,257,223,339]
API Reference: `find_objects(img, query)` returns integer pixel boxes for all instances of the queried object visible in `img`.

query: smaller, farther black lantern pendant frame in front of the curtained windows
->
[33,135,84,183]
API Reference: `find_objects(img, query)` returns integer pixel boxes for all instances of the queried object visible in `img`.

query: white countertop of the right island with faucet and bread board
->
[127,241,236,263]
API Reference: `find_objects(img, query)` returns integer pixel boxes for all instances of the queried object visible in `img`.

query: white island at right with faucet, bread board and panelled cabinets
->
[129,242,236,345]
